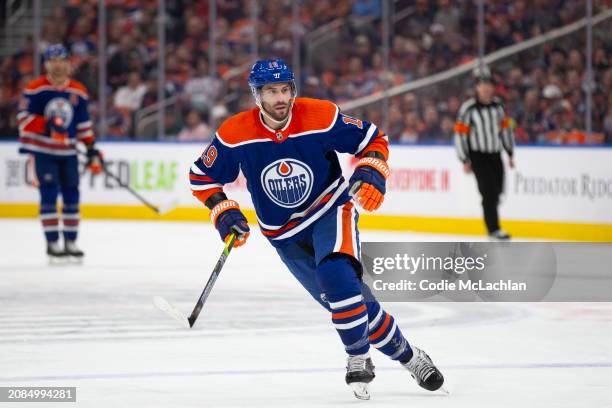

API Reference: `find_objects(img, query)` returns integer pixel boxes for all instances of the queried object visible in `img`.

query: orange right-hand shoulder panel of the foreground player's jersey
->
[291,98,340,133]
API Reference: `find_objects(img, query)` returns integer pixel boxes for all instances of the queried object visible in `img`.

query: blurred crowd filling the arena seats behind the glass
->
[0,0,612,144]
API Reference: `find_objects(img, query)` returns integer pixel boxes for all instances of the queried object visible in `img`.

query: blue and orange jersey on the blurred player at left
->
[17,76,94,156]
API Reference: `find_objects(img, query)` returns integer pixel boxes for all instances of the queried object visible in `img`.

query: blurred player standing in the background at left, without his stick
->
[17,44,102,260]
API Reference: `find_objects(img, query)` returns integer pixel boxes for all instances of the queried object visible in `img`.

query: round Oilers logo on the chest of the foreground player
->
[261,158,313,208]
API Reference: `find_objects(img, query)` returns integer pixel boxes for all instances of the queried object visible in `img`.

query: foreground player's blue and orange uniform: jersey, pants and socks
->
[189,98,412,361]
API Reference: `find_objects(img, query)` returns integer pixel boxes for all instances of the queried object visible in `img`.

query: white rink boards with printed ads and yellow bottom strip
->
[0,142,612,242]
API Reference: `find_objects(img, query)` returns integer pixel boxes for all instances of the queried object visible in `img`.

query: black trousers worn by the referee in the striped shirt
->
[470,152,504,234]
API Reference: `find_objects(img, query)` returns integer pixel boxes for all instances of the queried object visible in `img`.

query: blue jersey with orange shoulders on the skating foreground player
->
[189,98,388,246]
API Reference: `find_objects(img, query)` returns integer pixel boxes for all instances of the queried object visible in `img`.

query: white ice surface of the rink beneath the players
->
[0,220,612,408]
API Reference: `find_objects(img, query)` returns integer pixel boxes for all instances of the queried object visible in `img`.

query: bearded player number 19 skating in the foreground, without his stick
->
[189,59,444,399]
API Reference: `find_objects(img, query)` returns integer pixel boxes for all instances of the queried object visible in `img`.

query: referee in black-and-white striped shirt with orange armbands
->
[455,67,514,240]
